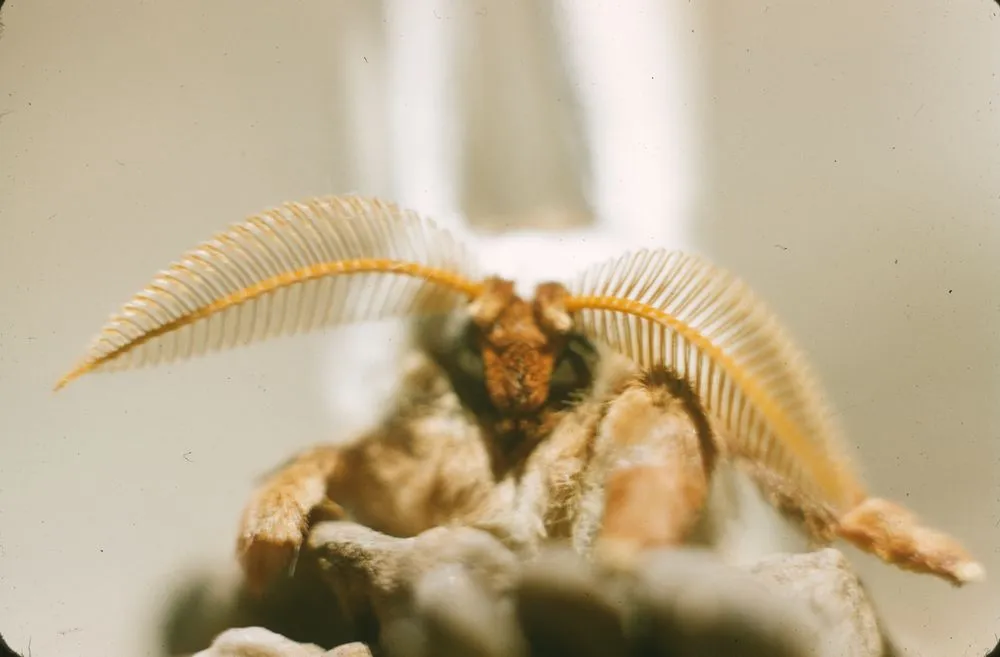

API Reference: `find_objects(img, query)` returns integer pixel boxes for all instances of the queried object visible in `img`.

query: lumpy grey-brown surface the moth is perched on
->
[171,523,903,657]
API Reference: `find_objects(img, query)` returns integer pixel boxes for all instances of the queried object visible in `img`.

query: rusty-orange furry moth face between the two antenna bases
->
[468,277,573,415]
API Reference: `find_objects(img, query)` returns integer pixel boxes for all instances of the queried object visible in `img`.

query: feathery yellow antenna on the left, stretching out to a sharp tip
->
[55,196,481,390]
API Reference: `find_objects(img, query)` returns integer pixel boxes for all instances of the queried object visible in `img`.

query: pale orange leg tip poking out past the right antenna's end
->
[836,498,985,585]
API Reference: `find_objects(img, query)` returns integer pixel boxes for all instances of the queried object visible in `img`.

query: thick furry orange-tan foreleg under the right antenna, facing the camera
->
[596,370,715,556]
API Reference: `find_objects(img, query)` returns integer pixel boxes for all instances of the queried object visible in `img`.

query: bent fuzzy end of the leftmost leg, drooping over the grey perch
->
[236,445,344,595]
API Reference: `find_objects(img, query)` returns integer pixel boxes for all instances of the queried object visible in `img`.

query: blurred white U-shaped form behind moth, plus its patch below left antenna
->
[316,0,698,452]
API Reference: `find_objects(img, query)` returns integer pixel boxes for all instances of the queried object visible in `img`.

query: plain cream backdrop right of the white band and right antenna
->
[693,0,1000,657]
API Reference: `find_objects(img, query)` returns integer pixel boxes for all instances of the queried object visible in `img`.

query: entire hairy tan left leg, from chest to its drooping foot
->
[238,406,492,593]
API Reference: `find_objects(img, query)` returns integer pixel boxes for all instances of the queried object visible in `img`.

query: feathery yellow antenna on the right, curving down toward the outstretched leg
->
[566,250,866,512]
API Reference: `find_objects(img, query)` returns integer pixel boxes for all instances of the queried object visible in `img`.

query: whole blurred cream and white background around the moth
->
[0,0,1000,657]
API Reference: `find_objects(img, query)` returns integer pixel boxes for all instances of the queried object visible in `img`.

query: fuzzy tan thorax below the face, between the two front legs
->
[330,344,636,552]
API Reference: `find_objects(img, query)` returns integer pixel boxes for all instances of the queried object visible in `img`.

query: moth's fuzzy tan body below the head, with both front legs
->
[239,330,715,590]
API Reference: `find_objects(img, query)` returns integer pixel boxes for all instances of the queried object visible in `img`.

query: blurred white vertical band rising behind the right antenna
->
[554,0,700,247]
